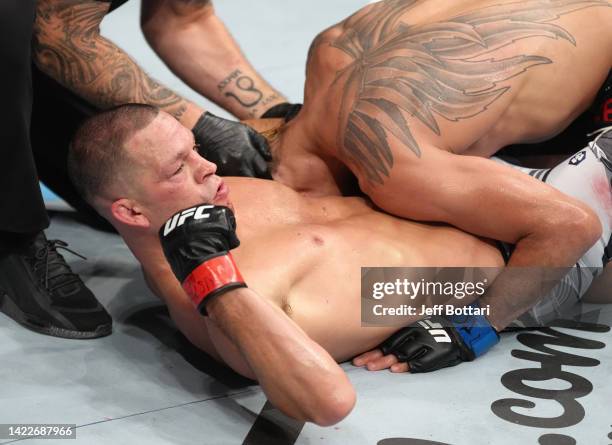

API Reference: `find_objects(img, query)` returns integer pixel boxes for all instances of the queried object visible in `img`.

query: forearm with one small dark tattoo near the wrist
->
[141,0,287,119]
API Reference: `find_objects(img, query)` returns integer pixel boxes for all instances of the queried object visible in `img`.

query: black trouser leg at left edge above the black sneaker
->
[0,0,49,233]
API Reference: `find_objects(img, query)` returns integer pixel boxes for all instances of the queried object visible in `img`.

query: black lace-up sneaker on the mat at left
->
[0,232,112,339]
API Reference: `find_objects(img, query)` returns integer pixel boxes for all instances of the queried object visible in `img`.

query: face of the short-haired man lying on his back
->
[127,113,231,230]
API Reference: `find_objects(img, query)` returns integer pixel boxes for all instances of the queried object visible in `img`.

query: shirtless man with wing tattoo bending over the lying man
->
[225,0,612,370]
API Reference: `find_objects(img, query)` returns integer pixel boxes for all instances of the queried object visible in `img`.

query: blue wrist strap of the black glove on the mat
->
[448,303,499,358]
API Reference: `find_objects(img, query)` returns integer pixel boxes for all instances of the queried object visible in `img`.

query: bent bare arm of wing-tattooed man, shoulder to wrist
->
[364,142,601,331]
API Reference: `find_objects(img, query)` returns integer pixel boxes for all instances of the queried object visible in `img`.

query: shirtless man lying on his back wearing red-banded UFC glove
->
[69,105,612,425]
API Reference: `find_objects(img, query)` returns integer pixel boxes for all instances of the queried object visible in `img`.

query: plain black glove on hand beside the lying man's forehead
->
[191,111,272,179]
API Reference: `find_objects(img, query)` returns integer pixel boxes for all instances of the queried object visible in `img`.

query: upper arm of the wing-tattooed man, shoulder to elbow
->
[360,147,560,243]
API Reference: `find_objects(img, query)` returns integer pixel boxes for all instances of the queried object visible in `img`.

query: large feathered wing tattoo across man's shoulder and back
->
[333,0,610,184]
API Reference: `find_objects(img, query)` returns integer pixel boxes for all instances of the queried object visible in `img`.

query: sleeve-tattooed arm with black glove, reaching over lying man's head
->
[33,0,269,177]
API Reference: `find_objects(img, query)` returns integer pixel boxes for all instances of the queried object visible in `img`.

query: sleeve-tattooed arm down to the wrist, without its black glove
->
[33,0,203,128]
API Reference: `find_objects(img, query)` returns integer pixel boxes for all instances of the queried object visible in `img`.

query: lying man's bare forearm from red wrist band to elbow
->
[207,289,354,425]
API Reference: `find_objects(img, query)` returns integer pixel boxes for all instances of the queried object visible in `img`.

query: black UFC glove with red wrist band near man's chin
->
[159,205,246,315]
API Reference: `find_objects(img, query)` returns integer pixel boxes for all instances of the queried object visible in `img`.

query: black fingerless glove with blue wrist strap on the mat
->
[379,303,499,373]
